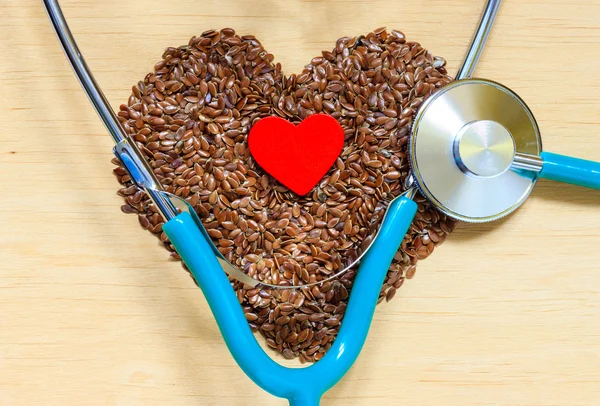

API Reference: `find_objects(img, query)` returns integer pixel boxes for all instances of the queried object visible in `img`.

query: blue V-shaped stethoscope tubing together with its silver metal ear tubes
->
[43,0,500,406]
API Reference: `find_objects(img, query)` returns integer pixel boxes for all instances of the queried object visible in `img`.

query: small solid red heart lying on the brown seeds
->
[248,114,344,196]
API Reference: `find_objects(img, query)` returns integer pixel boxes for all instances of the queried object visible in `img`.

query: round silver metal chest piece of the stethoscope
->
[409,79,542,222]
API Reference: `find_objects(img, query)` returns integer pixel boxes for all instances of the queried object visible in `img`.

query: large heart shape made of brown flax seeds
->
[114,28,455,362]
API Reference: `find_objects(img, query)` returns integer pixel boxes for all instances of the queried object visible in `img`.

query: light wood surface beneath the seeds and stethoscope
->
[0,0,600,406]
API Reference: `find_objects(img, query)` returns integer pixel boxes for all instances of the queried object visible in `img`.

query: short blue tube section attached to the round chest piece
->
[539,152,600,189]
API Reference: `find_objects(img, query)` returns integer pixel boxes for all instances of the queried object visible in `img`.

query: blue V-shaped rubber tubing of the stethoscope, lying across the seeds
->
[163,197,417,406]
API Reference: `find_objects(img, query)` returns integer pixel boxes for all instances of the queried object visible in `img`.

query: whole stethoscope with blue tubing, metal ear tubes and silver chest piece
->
[43,0,600,405]
